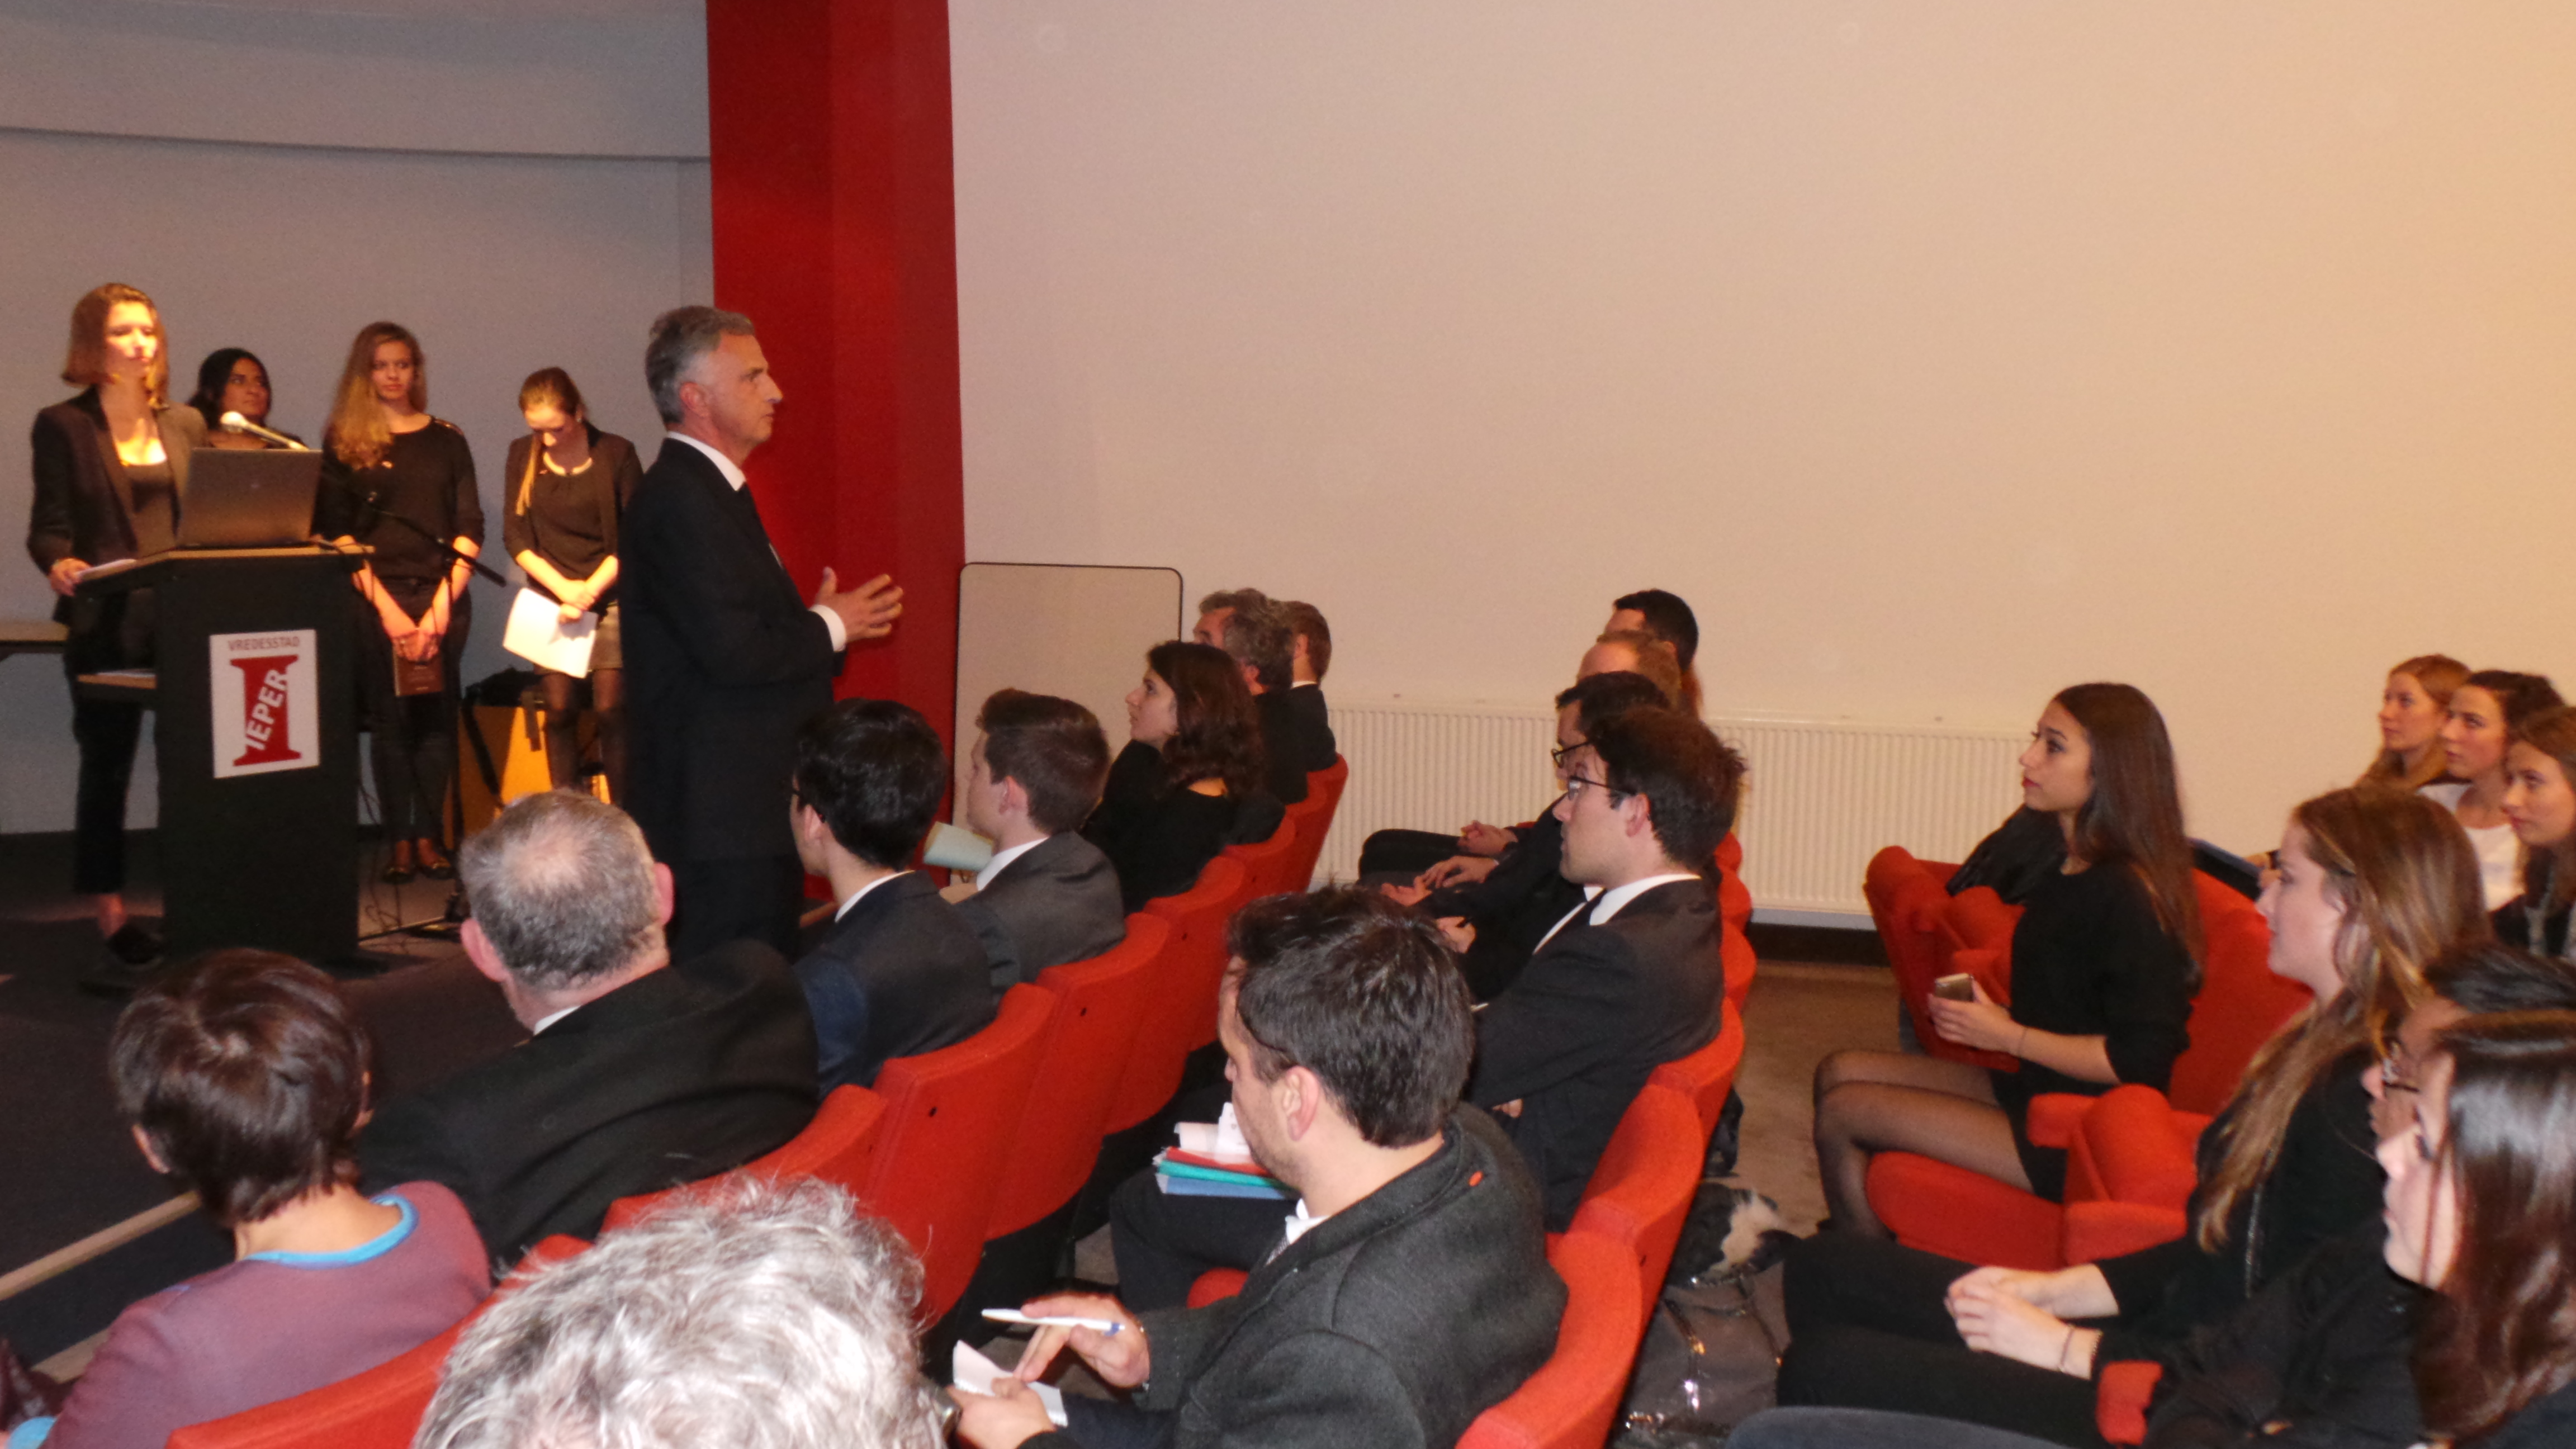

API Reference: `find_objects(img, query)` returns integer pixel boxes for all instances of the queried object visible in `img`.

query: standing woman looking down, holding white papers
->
[500,366,644,799]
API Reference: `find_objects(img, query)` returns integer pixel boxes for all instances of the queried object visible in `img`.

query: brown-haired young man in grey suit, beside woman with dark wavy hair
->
[958,688,1126,993]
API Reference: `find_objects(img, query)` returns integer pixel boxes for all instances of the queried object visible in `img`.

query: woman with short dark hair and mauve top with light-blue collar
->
[8,951,492,1449]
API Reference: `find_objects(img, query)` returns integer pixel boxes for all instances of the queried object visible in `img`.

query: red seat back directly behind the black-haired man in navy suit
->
[858,985,1056,1323]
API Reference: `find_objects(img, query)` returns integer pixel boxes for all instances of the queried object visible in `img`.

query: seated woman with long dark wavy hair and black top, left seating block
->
[1082,640,1280,910]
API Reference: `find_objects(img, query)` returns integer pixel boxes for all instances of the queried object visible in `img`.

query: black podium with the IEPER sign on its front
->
[75,547,368,962]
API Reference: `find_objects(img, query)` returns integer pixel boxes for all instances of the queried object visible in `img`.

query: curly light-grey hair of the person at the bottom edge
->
[412,1178,940,1449]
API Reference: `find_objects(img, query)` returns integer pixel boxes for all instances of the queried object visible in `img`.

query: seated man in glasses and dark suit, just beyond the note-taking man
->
[1469,709,1744,1233]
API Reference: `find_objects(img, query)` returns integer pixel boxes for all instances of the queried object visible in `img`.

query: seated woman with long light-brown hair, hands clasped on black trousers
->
[1780,789,2486,1444]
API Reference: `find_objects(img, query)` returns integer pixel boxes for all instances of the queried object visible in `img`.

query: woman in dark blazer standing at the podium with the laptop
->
[26,281,206,967]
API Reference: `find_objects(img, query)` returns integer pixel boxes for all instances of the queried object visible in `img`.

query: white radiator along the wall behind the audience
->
[1317,699,2025,926]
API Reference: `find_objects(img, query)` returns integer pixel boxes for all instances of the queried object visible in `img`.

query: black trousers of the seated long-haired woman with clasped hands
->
[1780,1233,2102,1449]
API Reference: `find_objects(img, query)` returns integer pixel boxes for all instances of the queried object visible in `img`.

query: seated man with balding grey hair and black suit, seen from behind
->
[358,789,814,1263]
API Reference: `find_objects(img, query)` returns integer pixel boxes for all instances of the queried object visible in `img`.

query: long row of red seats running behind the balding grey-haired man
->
[170,761,1350,1449]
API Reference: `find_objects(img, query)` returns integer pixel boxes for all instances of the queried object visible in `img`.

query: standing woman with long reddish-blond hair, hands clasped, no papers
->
[314,323,482,884]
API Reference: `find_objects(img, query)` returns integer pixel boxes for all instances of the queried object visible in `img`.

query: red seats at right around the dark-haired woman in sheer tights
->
[1863,846,2310,1444]
